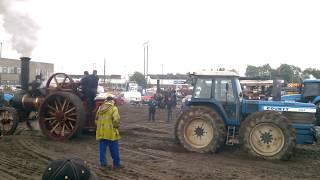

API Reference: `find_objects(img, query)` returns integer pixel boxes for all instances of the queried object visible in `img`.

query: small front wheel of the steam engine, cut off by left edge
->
[0,107,19,135]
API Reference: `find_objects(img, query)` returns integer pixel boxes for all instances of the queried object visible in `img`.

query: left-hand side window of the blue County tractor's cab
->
[193,78,212,99]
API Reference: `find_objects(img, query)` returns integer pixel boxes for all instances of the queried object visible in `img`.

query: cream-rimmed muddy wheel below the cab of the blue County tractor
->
[176,106,226,153]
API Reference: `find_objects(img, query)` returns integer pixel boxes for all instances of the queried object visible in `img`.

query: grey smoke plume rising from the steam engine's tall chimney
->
[0,0,39,56]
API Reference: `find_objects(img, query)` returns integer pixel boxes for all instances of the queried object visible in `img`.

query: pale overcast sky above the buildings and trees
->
[0,0,320,74]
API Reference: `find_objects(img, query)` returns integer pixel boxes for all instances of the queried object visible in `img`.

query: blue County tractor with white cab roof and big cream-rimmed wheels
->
[175,71,317,160]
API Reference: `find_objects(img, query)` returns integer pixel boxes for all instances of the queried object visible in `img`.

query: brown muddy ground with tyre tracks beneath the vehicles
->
[0,106,320,180]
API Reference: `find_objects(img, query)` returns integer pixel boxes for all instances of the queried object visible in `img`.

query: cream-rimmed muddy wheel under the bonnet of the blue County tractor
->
[240,111,296,160]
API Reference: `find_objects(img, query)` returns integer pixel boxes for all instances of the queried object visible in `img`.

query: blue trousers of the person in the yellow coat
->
[99,139,120,167]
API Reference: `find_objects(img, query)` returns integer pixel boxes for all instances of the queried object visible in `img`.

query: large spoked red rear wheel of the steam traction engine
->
[39,92,86,141]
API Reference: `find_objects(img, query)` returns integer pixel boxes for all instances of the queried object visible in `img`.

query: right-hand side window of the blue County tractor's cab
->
[214,79,235,102]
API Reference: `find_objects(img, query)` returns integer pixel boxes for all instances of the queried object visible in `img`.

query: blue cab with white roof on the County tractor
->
[189,71,242,125]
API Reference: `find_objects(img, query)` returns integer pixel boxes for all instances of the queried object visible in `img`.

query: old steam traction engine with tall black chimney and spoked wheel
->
[2,57,103,141]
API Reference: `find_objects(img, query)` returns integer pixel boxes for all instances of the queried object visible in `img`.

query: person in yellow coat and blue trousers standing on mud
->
[95,96,122,168]
